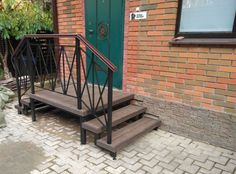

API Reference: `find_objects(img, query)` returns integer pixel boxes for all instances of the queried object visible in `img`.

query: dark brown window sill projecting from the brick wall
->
[169,38,236,46]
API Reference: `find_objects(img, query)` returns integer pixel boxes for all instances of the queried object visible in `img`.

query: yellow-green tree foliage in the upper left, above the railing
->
[0,0,53,39]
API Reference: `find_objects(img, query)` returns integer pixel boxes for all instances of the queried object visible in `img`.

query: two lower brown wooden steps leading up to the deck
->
[82,94,161,159]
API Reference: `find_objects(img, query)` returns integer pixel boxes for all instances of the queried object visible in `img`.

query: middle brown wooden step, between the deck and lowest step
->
[82,105,146,134]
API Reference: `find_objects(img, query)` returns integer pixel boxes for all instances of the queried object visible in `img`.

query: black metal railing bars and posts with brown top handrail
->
[12,34,117,144]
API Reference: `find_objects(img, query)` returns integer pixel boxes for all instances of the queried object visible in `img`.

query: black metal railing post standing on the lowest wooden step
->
[107,68,113,144]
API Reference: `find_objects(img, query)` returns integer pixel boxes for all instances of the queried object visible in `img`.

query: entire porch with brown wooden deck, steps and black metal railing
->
[12,34,161,159]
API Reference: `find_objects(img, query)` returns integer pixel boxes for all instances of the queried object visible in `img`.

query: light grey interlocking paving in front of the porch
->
[0,101,236,174]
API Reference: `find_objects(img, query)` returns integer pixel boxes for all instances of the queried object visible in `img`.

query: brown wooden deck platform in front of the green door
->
[29,86,134,117]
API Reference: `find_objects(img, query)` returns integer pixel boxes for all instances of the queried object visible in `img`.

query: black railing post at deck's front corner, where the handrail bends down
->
[75,38,83,109]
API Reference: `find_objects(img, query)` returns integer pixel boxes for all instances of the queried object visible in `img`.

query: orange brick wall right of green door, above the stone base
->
[124,0,236,114]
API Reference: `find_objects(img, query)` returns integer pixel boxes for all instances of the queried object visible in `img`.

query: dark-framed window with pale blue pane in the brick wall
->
[176,0,236,38]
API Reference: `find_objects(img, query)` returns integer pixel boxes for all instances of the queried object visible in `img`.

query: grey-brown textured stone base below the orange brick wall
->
[135,95,236,150]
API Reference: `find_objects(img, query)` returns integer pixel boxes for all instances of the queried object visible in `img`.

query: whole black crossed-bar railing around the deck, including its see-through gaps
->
[12,34,117,144]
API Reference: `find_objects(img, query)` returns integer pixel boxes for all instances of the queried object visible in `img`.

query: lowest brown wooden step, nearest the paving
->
[97,117,161,153]
